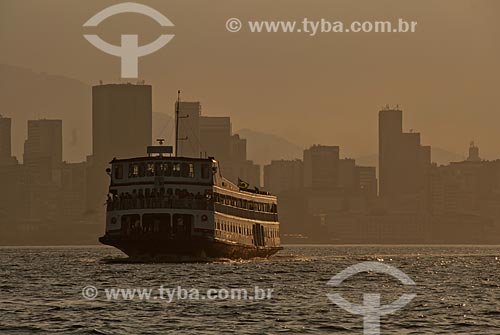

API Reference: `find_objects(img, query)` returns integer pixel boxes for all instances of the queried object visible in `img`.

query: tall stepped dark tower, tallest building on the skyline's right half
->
[379,107,431,201]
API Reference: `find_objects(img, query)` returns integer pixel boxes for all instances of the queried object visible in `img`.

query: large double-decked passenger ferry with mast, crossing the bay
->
[99,93,282,261]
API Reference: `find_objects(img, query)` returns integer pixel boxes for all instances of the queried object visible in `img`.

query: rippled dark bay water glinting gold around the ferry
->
[0,246,500,335]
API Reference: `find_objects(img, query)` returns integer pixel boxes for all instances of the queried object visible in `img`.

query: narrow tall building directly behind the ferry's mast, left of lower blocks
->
[176,101,201,158]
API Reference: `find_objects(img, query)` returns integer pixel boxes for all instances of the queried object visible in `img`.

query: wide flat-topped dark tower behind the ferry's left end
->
[92,84,153,163]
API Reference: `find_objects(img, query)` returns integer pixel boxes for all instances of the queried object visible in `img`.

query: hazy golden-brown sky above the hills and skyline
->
[0,0,500,158]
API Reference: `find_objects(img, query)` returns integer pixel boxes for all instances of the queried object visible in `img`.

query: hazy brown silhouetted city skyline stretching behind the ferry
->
[0,82,500,243]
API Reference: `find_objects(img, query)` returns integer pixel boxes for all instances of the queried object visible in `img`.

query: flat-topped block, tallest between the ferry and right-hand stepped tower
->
[304,145,339,189]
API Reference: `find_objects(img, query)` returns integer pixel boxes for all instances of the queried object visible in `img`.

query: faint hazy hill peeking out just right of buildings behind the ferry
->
[235,129,303,164]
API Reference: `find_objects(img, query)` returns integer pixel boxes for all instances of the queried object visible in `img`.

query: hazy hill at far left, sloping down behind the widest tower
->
[0,64,92,162]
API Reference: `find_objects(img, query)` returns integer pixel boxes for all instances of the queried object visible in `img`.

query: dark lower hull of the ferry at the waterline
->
[99,235,283,261]
